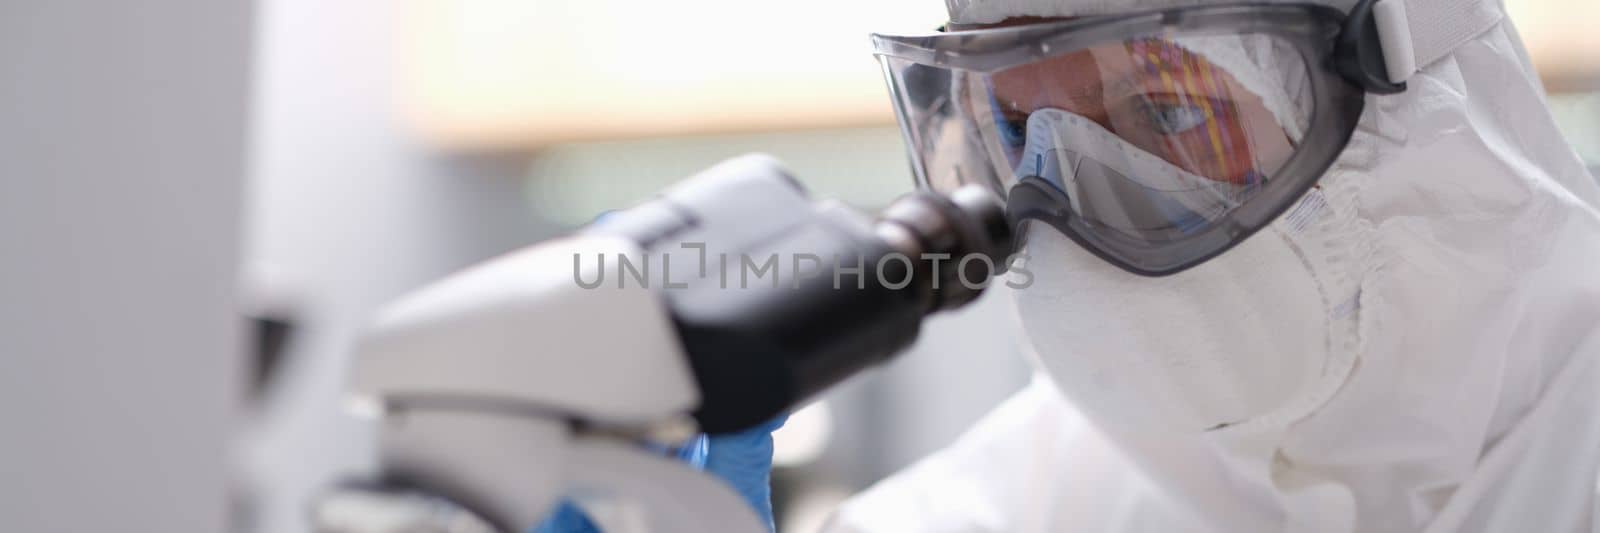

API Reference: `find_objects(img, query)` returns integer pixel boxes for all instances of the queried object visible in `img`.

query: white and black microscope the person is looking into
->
[312,155,1013,533]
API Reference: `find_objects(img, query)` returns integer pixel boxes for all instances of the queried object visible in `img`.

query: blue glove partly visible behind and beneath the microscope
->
[530,415,789,533]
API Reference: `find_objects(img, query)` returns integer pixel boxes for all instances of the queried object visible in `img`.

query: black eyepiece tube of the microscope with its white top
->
[592,157,1011,434]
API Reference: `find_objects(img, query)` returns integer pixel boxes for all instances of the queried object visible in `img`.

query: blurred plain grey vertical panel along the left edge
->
[0,0,251,533]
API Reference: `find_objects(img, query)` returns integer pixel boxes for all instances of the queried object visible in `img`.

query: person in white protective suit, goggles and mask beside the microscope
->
[560,0,1600,531]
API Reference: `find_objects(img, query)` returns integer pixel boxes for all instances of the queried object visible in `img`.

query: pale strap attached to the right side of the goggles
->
[1373,0,1504,83]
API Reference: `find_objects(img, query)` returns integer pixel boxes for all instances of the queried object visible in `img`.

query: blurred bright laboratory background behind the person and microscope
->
[0,0,1600,533]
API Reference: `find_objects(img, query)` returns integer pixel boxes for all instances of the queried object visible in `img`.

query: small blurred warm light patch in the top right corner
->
[1506,0,1600,91]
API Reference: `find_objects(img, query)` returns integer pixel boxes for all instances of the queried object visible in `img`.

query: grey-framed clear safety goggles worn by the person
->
[874,5,1403,275]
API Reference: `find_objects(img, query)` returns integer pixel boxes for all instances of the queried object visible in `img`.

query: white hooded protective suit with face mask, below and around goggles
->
[829,0,1600,531]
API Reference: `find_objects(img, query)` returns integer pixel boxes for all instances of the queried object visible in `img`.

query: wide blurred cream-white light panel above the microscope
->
[397,0,944,149]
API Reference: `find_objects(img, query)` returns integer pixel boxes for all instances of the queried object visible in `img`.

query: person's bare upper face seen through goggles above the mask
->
[982,38,1293,186]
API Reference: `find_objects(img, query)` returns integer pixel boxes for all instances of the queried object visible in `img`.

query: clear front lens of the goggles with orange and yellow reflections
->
[968,37,1298,242]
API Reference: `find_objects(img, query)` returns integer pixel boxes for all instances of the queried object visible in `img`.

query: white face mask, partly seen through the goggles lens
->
[1016,109,1342,432]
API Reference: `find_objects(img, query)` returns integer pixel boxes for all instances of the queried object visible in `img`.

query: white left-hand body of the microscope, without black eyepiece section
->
[339,235,765,531]
